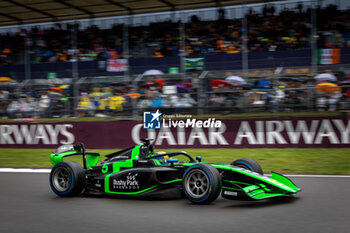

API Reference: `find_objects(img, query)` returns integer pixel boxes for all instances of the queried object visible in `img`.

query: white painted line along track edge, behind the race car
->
[0,168,350,178]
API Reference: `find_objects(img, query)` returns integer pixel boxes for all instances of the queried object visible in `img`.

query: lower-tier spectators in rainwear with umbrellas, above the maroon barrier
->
[0,71,350,118]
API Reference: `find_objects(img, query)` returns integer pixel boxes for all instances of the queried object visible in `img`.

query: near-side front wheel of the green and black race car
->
[182,164,221,204]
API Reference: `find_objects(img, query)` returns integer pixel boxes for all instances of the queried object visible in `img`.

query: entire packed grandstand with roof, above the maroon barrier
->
[0,0,350,118]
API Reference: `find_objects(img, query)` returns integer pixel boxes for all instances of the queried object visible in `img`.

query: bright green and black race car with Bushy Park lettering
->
[50,139,300,204]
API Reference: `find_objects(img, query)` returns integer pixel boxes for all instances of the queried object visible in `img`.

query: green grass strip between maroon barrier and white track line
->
[0,148,350,174]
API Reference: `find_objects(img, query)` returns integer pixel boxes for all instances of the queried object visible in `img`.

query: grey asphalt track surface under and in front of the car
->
[0,173,350,233]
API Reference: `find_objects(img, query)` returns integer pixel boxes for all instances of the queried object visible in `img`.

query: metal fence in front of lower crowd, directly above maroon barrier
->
[0,83,350,119]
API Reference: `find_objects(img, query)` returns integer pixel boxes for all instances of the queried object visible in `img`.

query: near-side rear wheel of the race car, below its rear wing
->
[50,161,85,197]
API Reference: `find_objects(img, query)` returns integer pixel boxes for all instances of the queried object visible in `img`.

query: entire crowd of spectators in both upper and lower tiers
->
[0,1,350,118]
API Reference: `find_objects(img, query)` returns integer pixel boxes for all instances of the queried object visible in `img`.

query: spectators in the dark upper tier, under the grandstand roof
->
[0,4,350,65]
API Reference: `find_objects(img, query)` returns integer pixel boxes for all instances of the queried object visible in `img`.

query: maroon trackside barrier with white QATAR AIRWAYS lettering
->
[0,116,350,149]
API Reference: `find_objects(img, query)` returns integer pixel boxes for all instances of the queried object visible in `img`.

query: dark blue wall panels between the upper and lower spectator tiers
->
[0,48,350,80]
